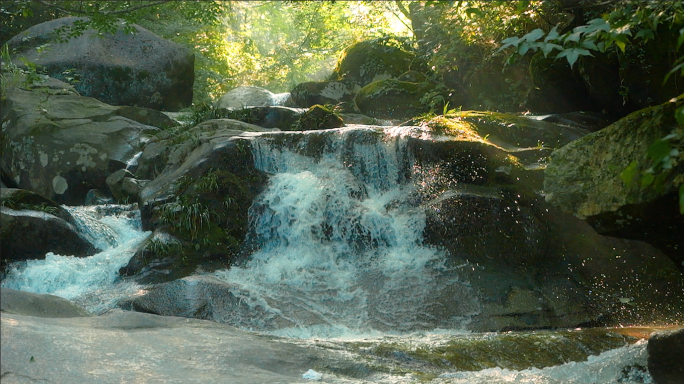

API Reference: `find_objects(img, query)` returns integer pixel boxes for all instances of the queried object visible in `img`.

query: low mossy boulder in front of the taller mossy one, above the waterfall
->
[354,79,435,119]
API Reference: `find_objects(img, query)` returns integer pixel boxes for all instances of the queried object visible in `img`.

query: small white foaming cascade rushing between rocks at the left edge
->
[2,206,150,313]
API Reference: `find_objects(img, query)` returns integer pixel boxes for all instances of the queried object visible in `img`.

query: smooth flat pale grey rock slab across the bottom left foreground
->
[1,311,342,383]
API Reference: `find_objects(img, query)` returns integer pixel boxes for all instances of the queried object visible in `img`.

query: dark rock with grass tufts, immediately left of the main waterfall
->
[122,119,268,282]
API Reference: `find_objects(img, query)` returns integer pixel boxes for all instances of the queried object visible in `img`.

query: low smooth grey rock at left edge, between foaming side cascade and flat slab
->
[0,288,90,318]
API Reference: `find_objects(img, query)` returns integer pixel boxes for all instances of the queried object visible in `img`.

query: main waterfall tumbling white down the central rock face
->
[215,128,479,337]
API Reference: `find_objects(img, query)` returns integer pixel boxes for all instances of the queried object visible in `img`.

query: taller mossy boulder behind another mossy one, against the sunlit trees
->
[332,41,415,88]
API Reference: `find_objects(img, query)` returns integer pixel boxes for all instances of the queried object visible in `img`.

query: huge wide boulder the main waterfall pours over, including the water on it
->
[122,121,684,331]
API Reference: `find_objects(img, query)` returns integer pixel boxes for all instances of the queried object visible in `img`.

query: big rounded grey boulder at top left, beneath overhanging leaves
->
[7,17,195,111]
